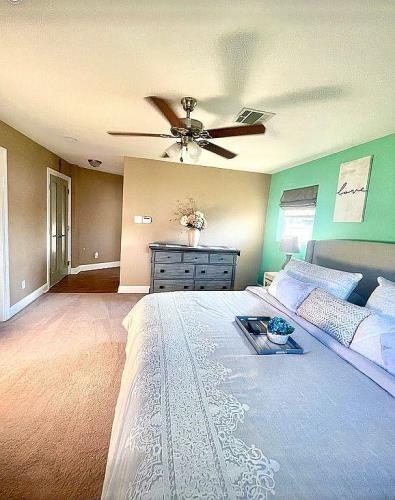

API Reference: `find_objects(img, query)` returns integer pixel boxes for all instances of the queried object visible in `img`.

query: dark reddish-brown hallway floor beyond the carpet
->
[49,267,119,293]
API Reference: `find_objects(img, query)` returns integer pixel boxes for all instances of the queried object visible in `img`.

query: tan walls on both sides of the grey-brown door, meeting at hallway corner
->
[0,122,122,305]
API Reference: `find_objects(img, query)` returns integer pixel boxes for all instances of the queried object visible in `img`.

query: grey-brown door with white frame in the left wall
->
[47,168,71,287]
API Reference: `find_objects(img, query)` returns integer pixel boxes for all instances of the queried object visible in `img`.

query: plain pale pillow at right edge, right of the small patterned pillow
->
[350,314,395,373]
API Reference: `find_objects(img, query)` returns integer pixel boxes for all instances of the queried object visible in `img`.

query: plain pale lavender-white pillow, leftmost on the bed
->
[268,271,316,312]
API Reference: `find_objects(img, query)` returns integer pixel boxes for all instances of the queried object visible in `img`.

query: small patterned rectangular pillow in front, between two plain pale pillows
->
[296,288,370,347]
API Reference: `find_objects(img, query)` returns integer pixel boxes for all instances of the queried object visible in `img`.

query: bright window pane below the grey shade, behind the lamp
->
[282,207,315,245]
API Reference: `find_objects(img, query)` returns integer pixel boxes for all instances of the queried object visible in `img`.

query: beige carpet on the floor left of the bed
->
[0,294,145,500]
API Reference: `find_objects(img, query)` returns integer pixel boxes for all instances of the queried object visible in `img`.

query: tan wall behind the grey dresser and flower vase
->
[121,158,270,289]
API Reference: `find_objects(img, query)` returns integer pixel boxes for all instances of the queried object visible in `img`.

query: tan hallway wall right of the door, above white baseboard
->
[71,166,123,267]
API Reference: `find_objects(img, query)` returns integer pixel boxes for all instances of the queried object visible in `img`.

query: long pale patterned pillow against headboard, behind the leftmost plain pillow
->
[284,259,362,299]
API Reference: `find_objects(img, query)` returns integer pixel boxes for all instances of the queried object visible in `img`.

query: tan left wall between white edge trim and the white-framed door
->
[0,122,63,305]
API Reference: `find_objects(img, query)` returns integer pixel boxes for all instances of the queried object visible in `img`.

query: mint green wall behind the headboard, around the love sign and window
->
[259,134,395,281]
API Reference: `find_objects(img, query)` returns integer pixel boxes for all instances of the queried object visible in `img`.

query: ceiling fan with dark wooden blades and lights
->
[107,96,266,162]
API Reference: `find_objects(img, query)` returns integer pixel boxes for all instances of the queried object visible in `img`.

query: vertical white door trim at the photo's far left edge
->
[0,147,10,321]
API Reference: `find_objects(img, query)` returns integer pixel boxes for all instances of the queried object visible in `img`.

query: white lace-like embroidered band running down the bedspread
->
[120,294,279,499]
